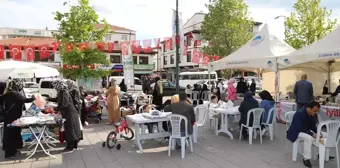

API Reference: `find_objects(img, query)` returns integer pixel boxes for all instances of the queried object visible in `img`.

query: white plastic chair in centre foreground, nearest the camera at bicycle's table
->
[168,114,194,159]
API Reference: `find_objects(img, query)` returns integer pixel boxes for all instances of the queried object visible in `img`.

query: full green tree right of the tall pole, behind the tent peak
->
[201,0,253,56]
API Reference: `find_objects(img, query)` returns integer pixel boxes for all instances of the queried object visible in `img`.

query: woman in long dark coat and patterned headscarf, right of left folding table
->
[52,80,81,151]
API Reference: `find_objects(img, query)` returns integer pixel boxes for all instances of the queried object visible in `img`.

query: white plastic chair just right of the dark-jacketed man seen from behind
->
[193,105,208,143]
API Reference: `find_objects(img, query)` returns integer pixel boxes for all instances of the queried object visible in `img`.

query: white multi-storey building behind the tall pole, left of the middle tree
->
[155,13,262,80]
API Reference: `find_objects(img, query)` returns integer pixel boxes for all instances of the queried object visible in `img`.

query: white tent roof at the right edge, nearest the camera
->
[278,27,340,71]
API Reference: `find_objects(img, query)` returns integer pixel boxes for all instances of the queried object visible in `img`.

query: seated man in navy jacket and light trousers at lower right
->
[287,101,320,167]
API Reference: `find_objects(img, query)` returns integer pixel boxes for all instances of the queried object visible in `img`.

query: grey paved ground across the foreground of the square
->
[0,120,336,168]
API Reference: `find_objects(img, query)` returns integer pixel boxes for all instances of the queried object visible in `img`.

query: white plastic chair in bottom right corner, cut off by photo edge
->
[313,120,340,168]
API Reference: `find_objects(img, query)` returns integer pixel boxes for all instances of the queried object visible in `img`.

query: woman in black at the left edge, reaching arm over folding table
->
[0,80,35,159]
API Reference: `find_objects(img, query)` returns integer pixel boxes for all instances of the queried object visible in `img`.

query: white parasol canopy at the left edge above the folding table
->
[0,60,59,80]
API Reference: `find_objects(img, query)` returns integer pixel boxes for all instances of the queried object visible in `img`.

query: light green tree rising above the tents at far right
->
[285,0,337,49]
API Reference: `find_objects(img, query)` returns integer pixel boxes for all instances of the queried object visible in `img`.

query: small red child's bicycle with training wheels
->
[102,117,135,150]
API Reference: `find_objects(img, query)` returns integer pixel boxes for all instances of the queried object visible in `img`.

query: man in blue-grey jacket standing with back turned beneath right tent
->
[294,74,313,110]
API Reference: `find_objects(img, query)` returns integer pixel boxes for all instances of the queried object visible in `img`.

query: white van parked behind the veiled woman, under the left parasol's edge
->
[39,78,60,98]
